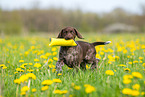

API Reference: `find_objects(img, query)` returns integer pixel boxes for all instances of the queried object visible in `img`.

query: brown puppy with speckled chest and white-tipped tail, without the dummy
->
[56,27,110,72]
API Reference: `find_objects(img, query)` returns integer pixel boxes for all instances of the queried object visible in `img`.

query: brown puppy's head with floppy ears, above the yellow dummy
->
[57,27,83,40]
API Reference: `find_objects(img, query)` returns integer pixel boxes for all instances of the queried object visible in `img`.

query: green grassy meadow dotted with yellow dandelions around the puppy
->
[0,34,145,97]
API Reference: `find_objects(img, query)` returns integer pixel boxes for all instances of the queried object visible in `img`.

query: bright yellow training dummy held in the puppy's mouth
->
[49,38,77,46]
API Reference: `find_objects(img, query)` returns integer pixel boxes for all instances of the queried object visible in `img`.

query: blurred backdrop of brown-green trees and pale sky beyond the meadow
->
[0,0,145,35]
